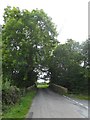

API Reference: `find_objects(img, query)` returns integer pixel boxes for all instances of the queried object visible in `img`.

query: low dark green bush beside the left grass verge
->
[2,82,21,111]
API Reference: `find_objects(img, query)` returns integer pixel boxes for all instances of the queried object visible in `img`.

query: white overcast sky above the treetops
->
[0,0,88,43]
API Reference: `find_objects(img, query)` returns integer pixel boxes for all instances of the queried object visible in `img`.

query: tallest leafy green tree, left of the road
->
[2,6,57,86]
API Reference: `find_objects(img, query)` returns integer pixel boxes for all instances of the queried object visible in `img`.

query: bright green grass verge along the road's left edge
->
[2,91,36,120]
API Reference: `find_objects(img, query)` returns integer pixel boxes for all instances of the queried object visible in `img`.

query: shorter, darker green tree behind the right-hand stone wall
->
[49,39,88,93]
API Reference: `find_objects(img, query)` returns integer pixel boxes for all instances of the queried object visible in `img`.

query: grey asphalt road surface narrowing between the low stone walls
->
[26,89,88,118]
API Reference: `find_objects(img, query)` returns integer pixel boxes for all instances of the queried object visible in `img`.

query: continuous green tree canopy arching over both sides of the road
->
[2,6,90,93]
